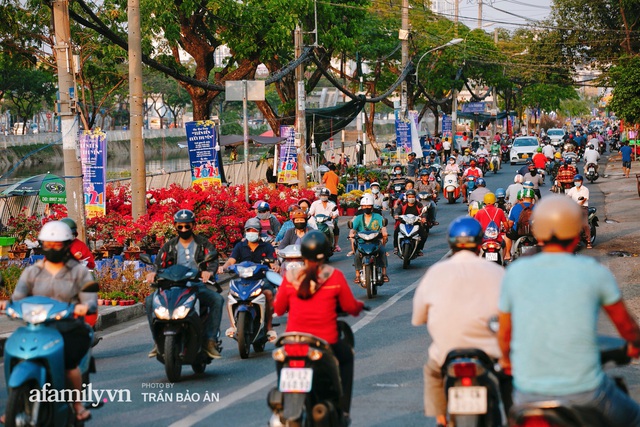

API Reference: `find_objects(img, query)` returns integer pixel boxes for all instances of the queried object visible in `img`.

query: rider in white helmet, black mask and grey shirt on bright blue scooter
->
[0,221,98,423]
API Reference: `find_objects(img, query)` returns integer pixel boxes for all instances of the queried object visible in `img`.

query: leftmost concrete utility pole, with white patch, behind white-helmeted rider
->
[53,0,85,241]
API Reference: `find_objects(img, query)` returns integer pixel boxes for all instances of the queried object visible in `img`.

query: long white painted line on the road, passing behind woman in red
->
[169,278,422,427]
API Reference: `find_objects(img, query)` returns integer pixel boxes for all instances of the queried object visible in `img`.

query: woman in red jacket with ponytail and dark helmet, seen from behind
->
[274,230,364,414]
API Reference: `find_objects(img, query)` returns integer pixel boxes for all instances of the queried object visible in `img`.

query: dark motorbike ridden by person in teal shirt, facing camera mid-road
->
[356,231,384,298]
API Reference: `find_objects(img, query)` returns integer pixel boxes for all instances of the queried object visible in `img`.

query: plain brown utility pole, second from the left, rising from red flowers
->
[127,0,147,220]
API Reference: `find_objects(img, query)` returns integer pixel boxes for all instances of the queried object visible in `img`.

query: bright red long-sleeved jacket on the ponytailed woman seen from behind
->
[273,265,364,344]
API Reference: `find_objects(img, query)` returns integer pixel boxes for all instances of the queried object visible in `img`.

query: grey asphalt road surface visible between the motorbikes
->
[0,162,620,426]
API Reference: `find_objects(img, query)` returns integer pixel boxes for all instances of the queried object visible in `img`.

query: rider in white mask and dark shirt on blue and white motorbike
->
[218,218,279,342]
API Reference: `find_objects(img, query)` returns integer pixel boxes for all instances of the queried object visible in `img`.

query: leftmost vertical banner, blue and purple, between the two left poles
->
[80,128,107,219]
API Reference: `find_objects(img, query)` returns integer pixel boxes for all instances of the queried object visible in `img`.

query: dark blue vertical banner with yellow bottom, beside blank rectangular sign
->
[185,120,222,188]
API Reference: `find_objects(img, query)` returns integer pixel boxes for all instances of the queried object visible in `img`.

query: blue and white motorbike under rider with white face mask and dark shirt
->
[227,260,279,359]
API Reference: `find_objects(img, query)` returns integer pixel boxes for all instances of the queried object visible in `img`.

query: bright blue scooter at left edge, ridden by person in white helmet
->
[4,283,101,426]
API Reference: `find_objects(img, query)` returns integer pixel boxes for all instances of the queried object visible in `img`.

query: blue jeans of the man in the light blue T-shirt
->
[514,377,640,427]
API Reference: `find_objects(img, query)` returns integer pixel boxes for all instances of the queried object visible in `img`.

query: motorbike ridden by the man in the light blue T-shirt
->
[509,336,631,427]
